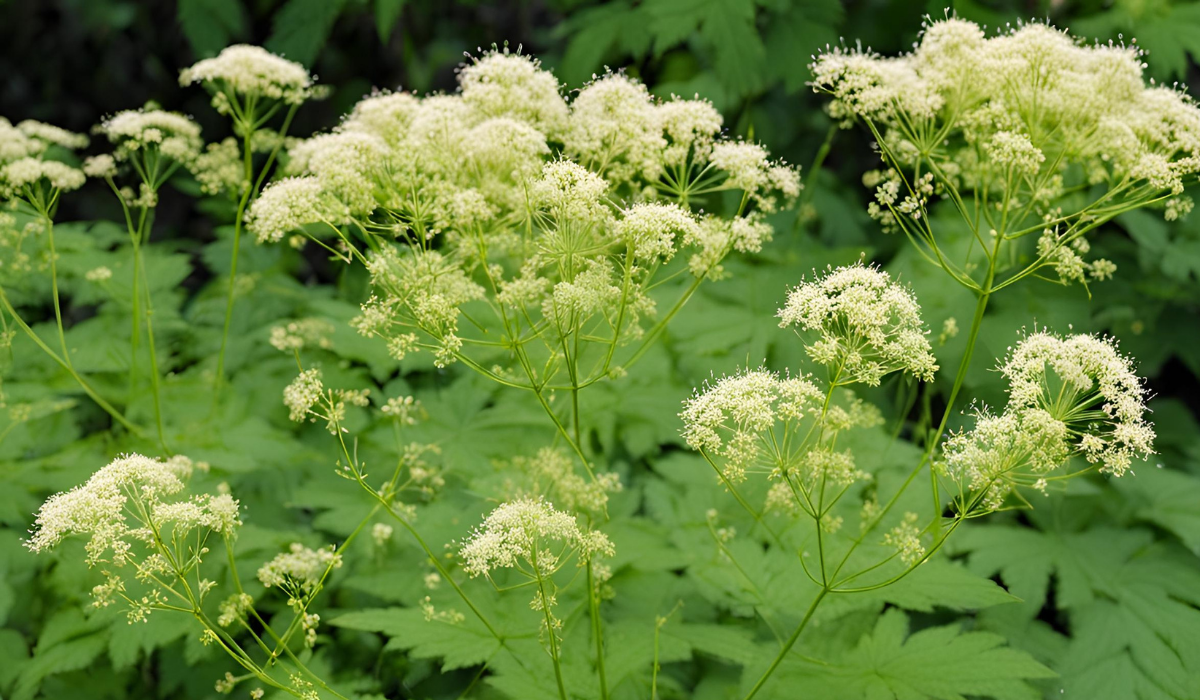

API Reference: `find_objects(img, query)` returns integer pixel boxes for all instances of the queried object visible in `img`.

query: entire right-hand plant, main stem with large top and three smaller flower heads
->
[657,18,1180,699]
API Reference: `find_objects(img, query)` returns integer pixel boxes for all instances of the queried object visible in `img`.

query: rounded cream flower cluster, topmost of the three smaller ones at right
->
[779,264,937,385]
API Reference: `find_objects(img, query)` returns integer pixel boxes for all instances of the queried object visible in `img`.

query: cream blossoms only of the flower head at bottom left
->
[25,454,241,567]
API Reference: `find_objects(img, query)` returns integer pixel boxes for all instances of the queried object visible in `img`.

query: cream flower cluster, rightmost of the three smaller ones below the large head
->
[942,331,1154,513]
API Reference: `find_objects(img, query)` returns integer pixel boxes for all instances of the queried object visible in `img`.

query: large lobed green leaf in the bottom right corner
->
[962,526,1200,700]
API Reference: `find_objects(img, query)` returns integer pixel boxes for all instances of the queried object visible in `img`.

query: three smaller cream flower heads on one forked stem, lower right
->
[680,264,1154,699]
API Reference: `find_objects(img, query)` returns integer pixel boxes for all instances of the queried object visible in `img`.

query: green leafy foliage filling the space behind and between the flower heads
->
[7,0,1200,700]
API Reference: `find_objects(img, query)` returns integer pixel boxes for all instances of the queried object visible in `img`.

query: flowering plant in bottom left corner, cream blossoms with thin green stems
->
[26,454,360,698]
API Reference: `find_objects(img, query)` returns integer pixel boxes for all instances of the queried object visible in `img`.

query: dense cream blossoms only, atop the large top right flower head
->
[810,18,1200,216]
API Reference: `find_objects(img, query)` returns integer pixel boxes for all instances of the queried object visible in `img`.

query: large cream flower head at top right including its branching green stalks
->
[811,18,1200,299]
